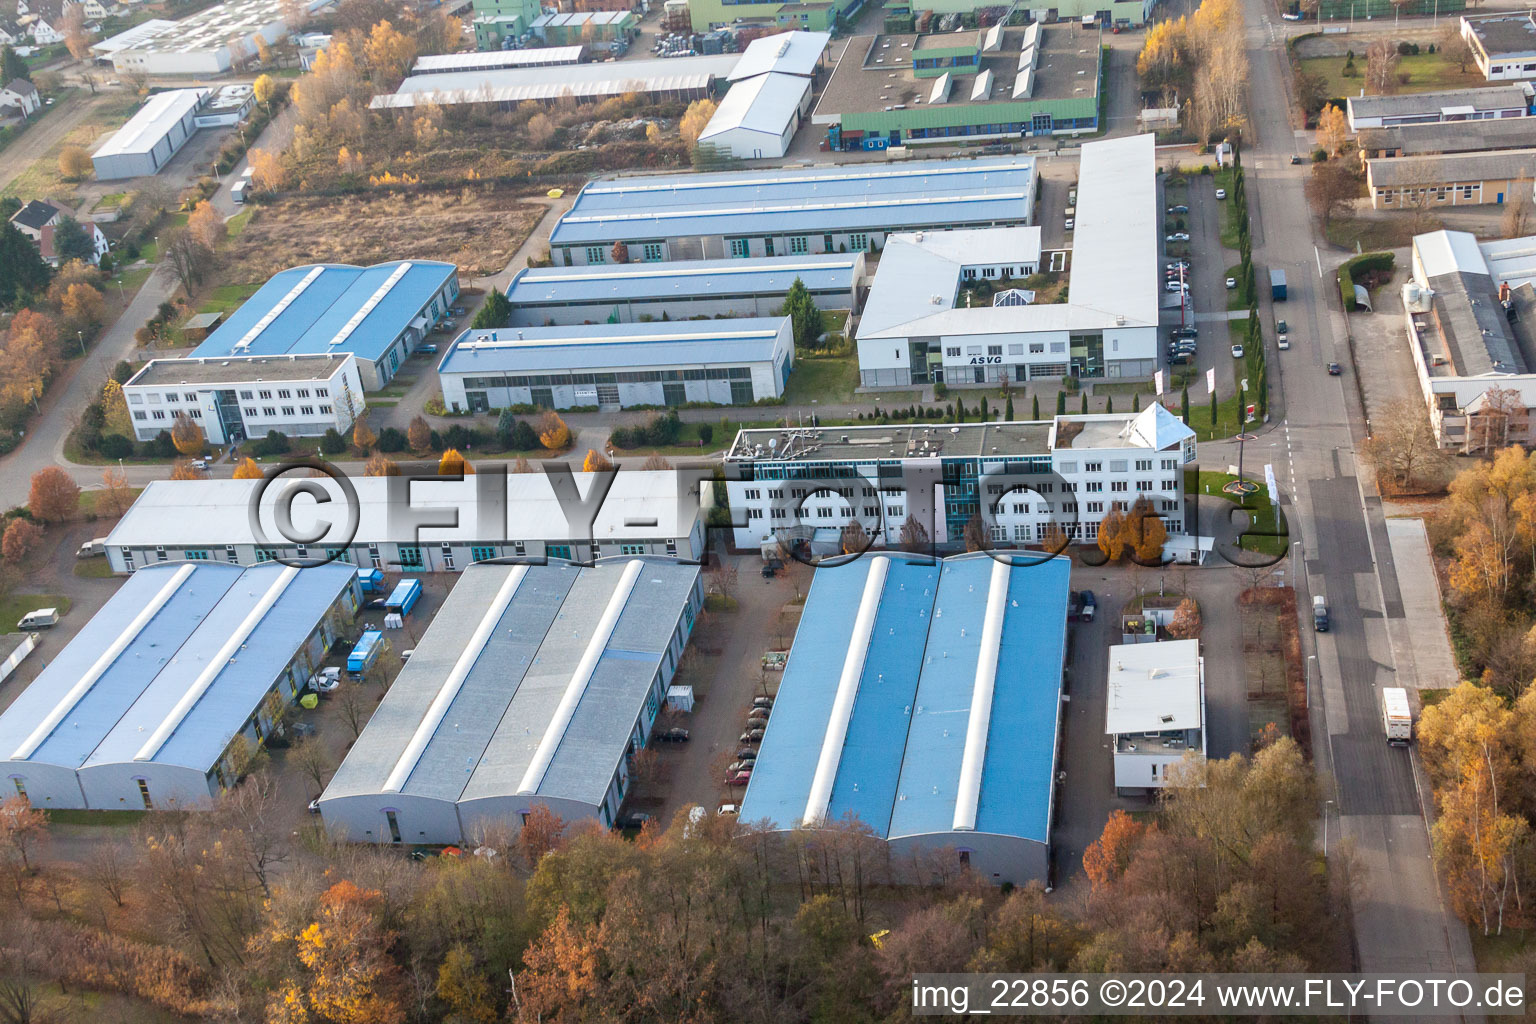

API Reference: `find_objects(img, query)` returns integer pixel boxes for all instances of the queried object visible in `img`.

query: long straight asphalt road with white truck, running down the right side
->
[1243,5,1475,972]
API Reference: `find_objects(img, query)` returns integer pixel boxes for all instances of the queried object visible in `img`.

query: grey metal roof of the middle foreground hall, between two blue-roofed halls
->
[324,559,699,806]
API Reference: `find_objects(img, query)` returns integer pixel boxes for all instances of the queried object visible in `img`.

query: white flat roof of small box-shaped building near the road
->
[1104,640,1206,735]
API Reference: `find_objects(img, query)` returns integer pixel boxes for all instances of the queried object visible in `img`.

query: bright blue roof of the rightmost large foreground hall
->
[742,554,1071,843]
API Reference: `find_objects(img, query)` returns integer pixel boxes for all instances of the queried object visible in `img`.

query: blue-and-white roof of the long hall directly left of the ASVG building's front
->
[438,316,790,373]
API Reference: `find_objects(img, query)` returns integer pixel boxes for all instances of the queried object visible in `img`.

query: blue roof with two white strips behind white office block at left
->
[192,259,456,366]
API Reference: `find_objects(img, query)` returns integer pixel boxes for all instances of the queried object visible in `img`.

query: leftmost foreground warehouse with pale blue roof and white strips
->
[0,562,358,811]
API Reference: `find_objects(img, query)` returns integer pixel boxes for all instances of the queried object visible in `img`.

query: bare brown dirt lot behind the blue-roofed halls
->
[221,187,544,277]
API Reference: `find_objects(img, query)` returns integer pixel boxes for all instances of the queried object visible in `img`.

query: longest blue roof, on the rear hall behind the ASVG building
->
[550,157,1034,246]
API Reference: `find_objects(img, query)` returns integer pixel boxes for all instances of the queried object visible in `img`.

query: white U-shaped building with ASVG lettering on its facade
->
[859,135,1160,387]
